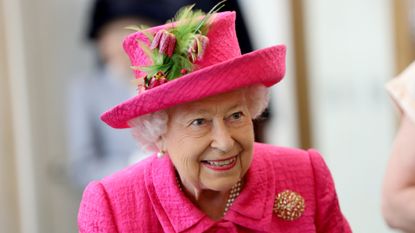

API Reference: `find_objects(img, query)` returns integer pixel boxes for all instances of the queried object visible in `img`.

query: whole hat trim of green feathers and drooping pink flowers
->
[129,0,226,90]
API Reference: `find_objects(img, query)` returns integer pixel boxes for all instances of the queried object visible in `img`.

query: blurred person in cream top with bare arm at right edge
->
[382,62,415,233]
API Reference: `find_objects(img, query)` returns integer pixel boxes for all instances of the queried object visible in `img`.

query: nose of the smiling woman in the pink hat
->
[211,121,235,153]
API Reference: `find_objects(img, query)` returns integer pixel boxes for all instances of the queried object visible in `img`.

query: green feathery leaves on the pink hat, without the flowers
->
[131,0,226,87]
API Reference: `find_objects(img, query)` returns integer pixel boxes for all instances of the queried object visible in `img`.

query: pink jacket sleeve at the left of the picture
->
[78,182,118,233]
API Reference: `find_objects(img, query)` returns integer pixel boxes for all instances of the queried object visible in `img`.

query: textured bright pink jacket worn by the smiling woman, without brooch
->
[78,144,351,233]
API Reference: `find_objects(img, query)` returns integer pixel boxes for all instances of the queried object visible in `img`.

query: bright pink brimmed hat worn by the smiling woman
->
[101,8,285,128]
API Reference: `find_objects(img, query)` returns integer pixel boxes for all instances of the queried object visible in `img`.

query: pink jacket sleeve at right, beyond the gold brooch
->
[309,150,352,233]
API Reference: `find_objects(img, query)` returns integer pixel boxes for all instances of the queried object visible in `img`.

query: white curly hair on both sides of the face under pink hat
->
[128,84,269,152]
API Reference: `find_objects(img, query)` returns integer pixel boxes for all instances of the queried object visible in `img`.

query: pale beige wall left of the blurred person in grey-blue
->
[0,0,91,233]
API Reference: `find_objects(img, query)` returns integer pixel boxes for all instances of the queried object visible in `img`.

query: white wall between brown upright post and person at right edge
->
[304,0,395,233]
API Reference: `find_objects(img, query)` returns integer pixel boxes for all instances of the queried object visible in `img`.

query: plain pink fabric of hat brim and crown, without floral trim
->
[101,12,286,128]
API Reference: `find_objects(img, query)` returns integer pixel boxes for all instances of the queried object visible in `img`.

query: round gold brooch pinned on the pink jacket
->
[274,190,305,221]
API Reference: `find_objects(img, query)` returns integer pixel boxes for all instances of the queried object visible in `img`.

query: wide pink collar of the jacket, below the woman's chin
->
[146,143,275,232]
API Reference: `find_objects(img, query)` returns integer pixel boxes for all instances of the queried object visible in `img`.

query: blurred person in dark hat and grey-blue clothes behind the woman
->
[68,0,258,189]
